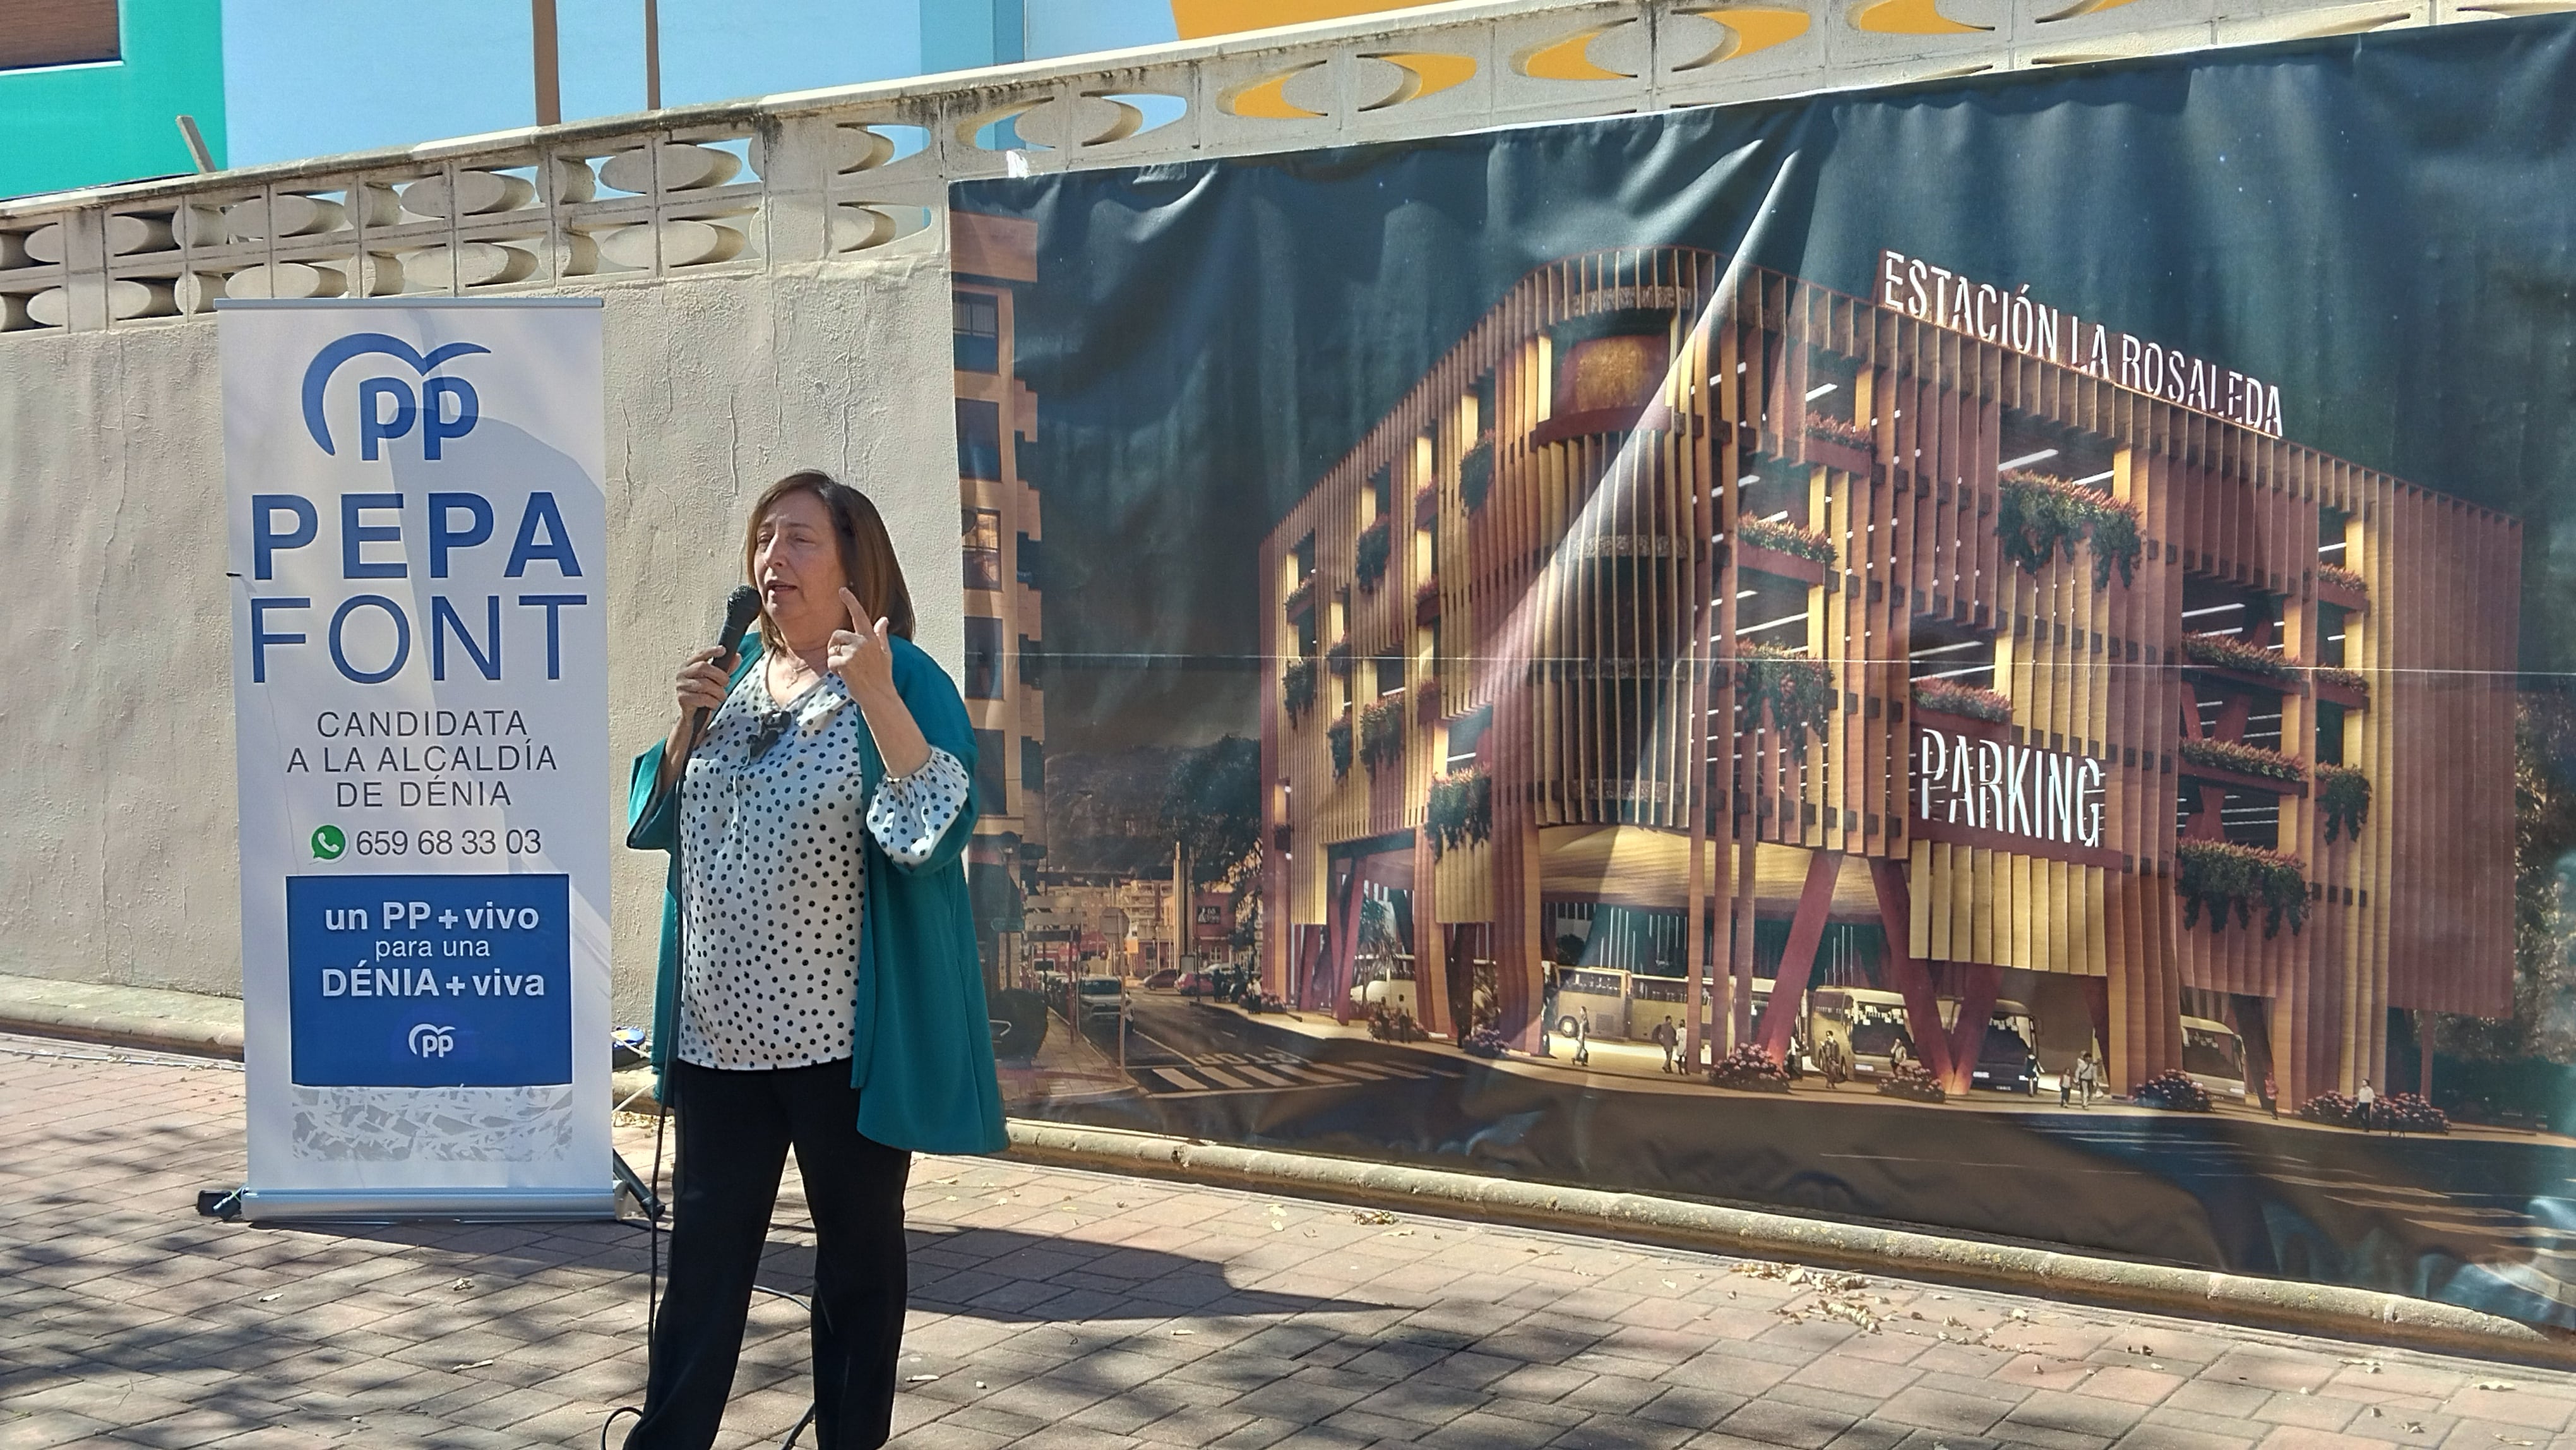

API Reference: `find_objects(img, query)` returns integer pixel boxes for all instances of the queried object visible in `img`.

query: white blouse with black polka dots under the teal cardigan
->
[672,669,969,1069]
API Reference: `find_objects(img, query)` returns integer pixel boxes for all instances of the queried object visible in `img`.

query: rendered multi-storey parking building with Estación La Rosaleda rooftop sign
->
[1260,248,2519,1102]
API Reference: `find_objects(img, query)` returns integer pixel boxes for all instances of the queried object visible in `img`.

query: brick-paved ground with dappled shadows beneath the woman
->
[0,1038,2576,1450]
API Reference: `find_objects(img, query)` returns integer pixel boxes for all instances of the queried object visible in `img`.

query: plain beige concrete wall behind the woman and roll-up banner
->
[0,255,963,1022]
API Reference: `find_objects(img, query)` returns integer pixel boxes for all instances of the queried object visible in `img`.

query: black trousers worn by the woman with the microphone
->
[626,1061,912,1450]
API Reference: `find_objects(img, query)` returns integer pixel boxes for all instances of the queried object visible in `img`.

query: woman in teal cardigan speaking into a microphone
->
[626,471,1005,1450]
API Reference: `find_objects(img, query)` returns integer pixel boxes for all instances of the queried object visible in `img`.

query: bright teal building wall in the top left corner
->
[0,0,224,196]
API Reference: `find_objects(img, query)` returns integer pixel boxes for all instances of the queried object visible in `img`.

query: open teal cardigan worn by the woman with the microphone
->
[626,636,1010,1154]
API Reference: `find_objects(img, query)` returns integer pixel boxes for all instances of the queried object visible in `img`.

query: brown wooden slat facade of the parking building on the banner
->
[1260,248,2519,1099]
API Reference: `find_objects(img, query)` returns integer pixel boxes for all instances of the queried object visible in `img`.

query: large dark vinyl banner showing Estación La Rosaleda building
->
[953,18,2576,1326]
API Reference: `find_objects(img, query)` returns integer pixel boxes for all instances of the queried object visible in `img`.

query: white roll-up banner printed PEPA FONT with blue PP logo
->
[217,299,616,1218]
